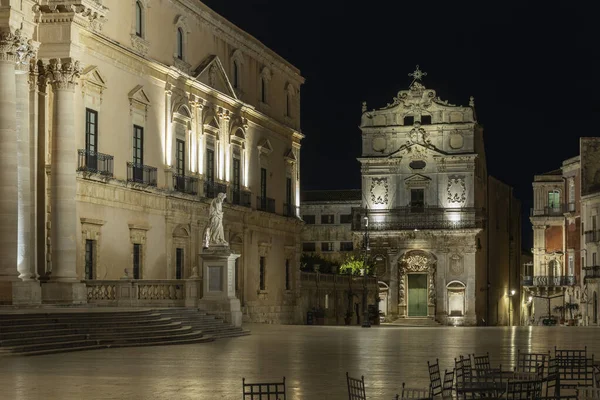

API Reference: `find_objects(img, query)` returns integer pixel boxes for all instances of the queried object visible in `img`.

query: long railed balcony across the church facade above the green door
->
[352,206,483,231]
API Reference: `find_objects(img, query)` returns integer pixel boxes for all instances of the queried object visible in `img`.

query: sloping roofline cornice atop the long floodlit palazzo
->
[170,0,304,84]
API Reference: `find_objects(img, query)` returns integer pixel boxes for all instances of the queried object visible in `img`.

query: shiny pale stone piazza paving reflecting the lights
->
[0,325,600,400]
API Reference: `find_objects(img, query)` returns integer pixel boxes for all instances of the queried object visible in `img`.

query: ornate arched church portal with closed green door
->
[398,250,437,318]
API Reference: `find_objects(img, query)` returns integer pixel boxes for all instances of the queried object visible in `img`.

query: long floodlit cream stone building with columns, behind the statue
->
[0,0,304,322]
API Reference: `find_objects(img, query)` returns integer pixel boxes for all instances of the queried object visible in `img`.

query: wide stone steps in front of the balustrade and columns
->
[0,308,250,355]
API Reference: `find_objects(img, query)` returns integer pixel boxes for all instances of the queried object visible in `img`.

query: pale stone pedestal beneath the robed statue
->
[198,245,242,327]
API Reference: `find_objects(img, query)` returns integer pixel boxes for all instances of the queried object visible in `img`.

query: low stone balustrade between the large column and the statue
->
[85,279,202,307]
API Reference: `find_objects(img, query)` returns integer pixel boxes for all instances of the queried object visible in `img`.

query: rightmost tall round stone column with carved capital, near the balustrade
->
[42,59,87,303]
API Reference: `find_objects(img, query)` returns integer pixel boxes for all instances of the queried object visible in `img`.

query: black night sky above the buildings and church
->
[204,0,600,248]
